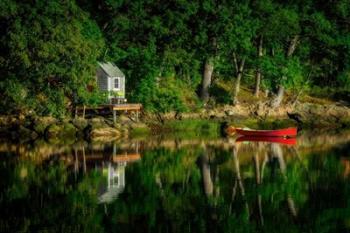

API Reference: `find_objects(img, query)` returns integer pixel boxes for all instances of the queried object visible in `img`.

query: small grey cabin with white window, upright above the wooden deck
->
[96,62,126,104]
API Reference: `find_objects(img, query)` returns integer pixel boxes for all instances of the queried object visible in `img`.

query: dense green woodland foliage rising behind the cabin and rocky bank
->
[0,0,350,115]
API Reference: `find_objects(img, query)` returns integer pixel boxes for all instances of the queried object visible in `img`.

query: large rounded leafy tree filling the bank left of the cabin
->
[0,0,103,116]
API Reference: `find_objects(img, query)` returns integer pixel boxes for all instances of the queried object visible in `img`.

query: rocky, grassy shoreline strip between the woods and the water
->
[0,102,350,141]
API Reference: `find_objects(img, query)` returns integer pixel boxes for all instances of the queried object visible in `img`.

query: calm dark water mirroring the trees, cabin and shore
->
[0,132,350,233]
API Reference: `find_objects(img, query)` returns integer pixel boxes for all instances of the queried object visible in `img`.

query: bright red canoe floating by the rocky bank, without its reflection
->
[226,126,297,137]
